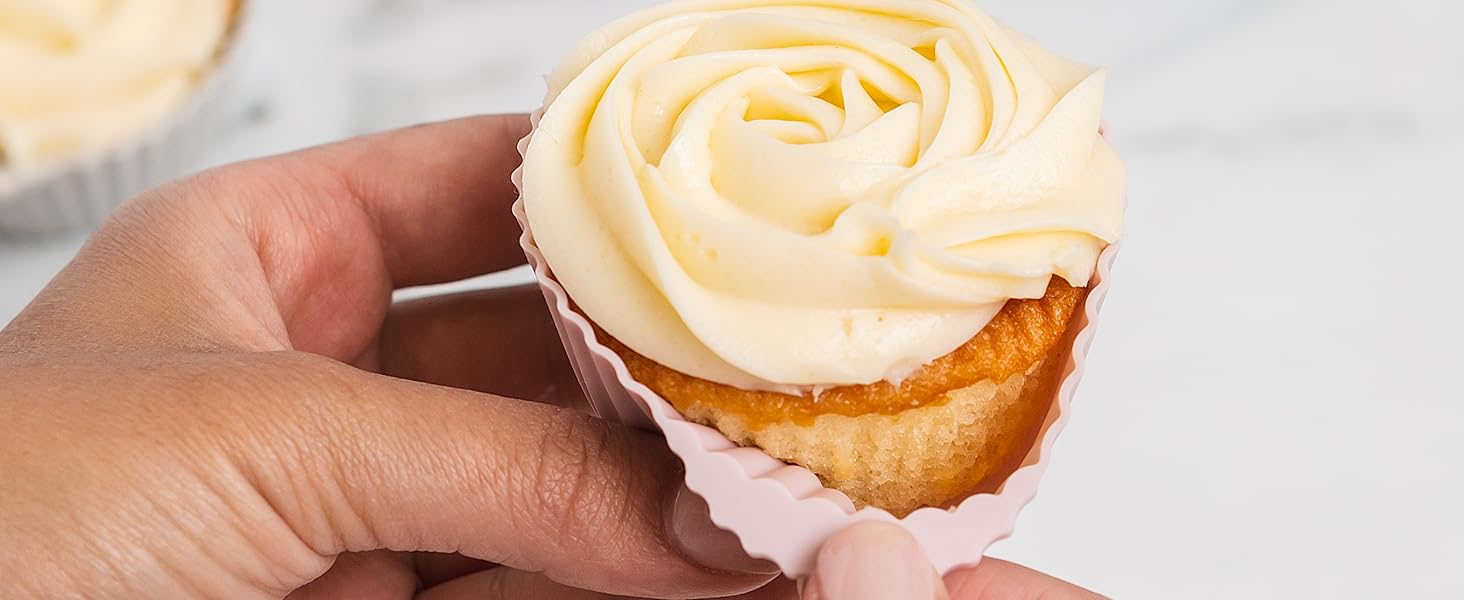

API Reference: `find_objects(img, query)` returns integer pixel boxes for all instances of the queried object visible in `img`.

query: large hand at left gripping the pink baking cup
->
[0,116,1100,599]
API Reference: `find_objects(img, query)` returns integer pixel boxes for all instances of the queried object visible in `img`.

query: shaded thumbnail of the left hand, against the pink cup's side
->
[666,484,777,575]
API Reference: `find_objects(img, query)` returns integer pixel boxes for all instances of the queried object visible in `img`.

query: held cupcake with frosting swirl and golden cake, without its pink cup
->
[520,0,1126,517]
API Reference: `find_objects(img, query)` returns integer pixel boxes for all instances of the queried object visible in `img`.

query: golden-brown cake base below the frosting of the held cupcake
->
[596,278,1088,517]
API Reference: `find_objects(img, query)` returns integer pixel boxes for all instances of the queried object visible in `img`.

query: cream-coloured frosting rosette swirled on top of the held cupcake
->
[523,0,1127,389]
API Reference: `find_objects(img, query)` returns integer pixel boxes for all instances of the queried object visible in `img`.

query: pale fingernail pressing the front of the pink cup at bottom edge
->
[802,521,947,600]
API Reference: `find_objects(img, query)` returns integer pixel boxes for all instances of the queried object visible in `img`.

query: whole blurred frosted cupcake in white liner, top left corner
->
[0,0,244,233]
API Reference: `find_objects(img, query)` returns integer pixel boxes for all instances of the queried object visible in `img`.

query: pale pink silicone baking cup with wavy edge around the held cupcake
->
[512,110,1118,578]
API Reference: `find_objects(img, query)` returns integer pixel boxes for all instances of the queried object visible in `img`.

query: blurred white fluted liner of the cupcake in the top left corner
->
[0,0,253,240]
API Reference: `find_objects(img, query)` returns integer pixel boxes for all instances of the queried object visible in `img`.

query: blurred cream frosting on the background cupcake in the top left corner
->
[0,0,233,168]
